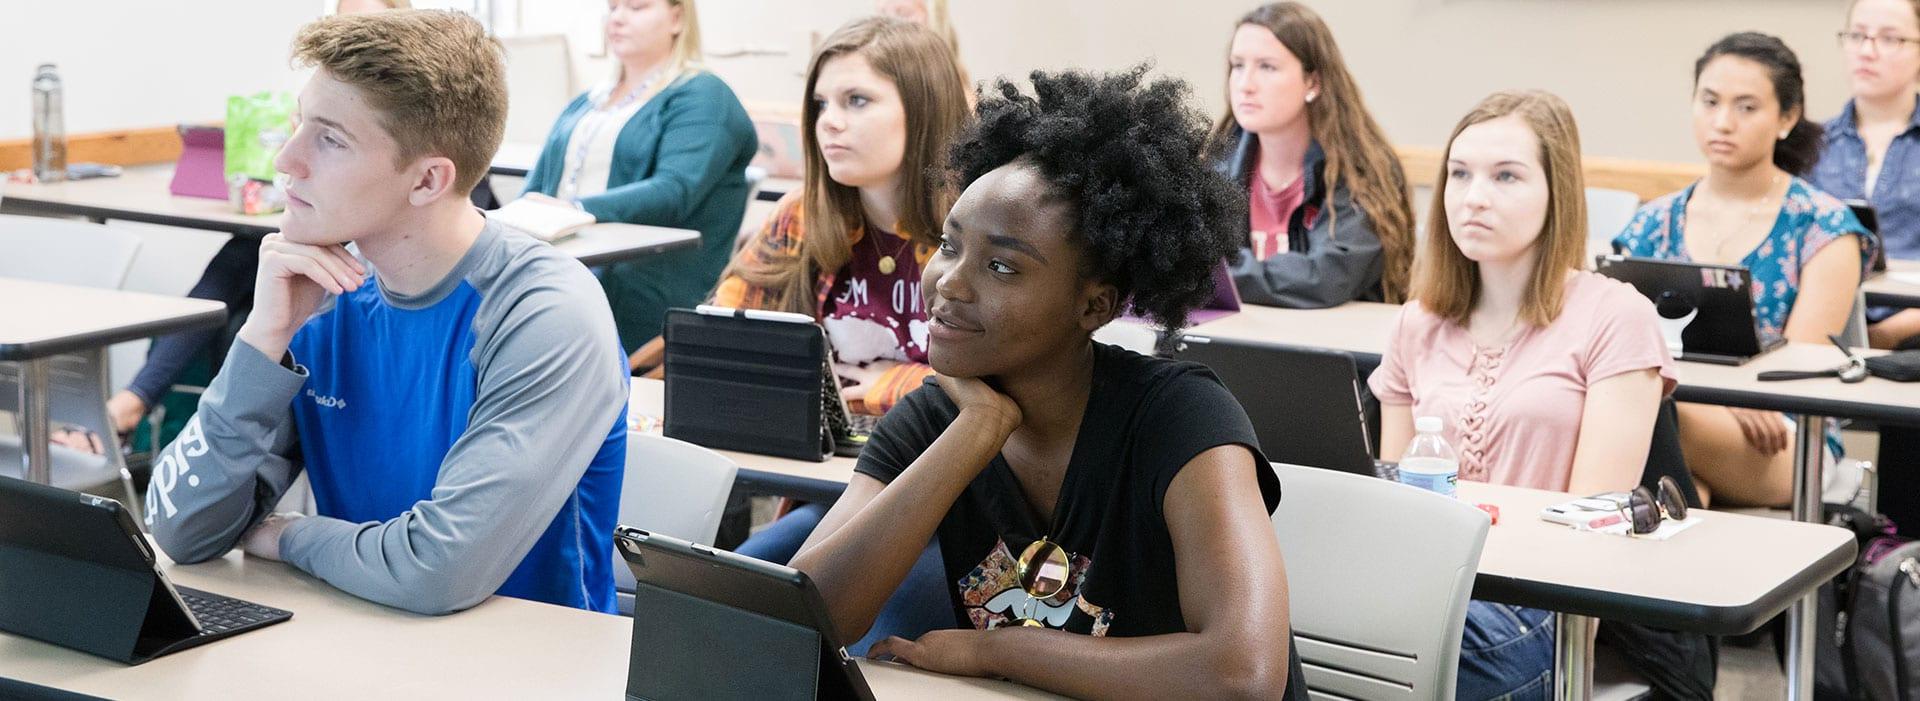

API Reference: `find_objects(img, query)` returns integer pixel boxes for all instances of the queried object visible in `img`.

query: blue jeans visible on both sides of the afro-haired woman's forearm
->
[733,503,948,657]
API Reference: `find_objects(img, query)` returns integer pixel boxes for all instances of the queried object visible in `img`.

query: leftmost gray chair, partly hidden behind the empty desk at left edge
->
[0,215,140,513]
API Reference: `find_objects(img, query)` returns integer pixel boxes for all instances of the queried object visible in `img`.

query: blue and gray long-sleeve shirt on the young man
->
[146,221,628,613]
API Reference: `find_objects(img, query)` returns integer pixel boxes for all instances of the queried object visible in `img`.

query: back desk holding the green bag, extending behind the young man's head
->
[0,165,701,265]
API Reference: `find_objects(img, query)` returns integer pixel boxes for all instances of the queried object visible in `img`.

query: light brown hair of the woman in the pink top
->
[1413,90,1586,326]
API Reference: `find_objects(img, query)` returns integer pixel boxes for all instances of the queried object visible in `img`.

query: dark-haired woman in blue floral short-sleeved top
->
[1613,33,1874,507]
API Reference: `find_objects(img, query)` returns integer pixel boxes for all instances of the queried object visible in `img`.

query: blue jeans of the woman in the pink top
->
[1453,599,1553,701]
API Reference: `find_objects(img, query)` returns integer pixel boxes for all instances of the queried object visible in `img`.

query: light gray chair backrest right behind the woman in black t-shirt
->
[1273,463,1488,699]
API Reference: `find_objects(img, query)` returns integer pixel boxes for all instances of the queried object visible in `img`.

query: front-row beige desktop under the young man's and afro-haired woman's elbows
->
[0,551,1056,699]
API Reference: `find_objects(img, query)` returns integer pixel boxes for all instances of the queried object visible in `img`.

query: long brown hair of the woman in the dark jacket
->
[1212,2,1413,303]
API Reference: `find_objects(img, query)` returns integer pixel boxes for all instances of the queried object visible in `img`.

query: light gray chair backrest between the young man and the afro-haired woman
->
[607,432,739,615]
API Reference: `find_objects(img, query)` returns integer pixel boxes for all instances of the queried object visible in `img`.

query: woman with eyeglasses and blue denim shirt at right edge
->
[1811,0,1920,348]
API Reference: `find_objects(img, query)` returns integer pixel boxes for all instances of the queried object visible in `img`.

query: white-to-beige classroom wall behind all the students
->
[0,0,1881,161]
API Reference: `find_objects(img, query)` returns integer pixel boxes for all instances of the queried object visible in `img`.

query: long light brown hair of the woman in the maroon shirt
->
[722,17,968,315]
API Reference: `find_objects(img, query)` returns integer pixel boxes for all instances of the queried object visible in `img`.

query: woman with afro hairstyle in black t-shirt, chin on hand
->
[793,67,1306,699]
